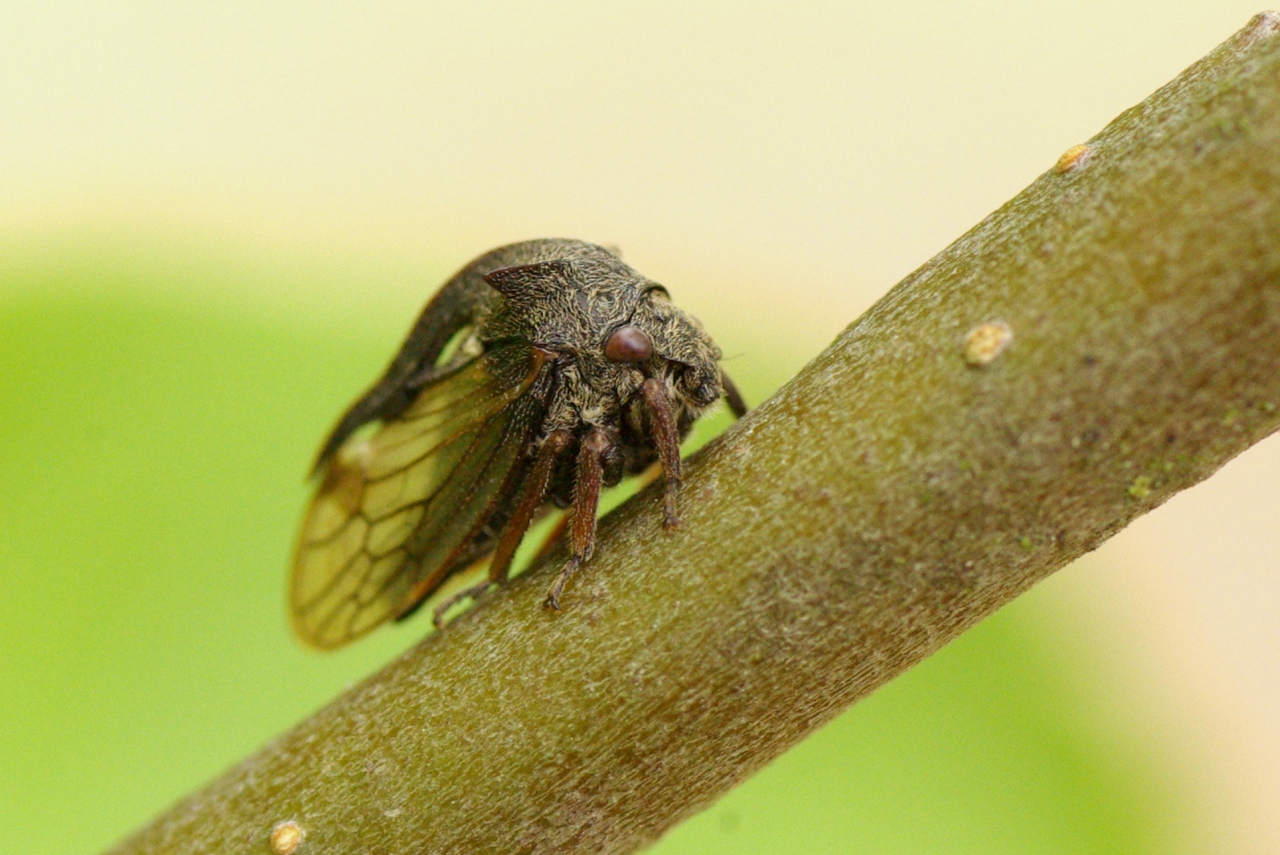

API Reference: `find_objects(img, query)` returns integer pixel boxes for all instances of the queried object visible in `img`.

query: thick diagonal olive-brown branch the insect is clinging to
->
[114,13,1280,855]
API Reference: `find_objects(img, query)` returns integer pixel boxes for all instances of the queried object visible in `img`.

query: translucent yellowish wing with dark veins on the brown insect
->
[289,346,547,648]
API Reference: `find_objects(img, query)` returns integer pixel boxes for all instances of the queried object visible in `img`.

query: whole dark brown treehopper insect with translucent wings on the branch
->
[289,239,746,648]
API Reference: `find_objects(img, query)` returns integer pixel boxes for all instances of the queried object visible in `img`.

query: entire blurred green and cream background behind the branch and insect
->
[0,0,1280,855]
